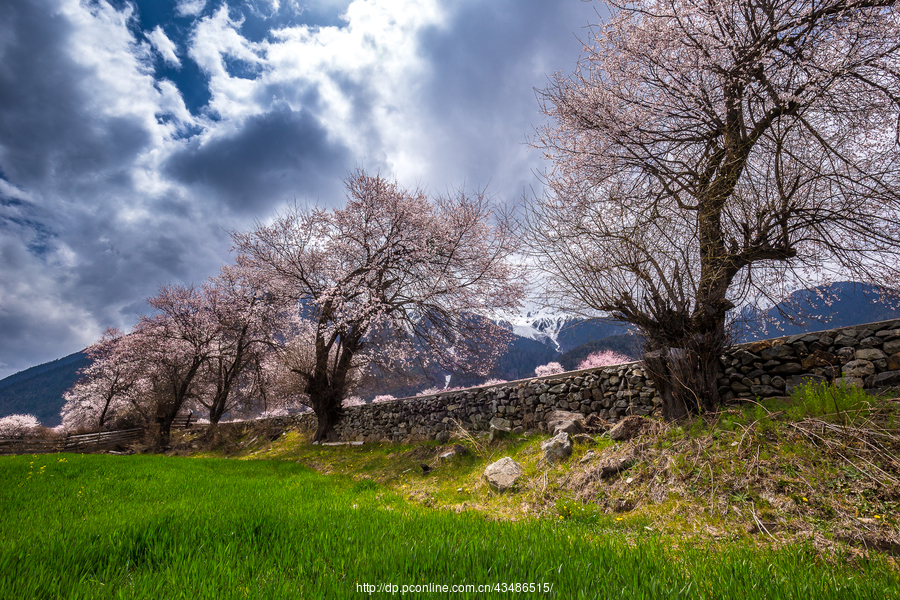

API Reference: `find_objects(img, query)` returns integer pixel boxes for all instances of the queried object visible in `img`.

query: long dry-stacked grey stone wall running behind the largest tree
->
[286,320,900,442]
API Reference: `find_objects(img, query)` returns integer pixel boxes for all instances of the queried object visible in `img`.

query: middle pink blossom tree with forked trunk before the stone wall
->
[233,171,524,440]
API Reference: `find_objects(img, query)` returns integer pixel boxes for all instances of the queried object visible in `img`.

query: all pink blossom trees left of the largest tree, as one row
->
[63,171,524,445]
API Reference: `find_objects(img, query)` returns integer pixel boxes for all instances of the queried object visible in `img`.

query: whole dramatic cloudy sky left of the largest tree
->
[0,0,597,377]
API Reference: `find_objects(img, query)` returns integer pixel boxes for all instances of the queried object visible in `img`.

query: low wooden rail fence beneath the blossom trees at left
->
[0,413,199,454]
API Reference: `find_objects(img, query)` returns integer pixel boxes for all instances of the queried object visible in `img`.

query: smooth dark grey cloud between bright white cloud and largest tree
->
[422,0,597,196]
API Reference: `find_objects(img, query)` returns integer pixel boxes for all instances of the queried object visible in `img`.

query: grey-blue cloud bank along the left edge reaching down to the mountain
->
[0,0,227,377]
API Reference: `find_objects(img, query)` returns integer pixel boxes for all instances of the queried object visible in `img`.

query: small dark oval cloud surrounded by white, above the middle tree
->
[165,103,352,212]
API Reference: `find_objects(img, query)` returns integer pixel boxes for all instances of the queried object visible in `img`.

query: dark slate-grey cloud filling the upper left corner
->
[0,0,149,186]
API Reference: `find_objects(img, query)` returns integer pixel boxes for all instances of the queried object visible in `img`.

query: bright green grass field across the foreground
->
[0,454,900,600]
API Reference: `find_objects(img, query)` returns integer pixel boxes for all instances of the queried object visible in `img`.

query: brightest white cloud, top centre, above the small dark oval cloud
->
[189,0,445,179]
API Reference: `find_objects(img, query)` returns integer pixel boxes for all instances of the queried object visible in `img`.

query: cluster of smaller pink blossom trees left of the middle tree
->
[62,266,291,442]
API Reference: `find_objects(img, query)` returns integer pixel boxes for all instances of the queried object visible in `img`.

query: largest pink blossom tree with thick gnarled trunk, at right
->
[529,0,900,419]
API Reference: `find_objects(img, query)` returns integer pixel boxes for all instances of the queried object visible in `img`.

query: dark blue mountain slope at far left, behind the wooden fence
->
[0,352,90,427]
